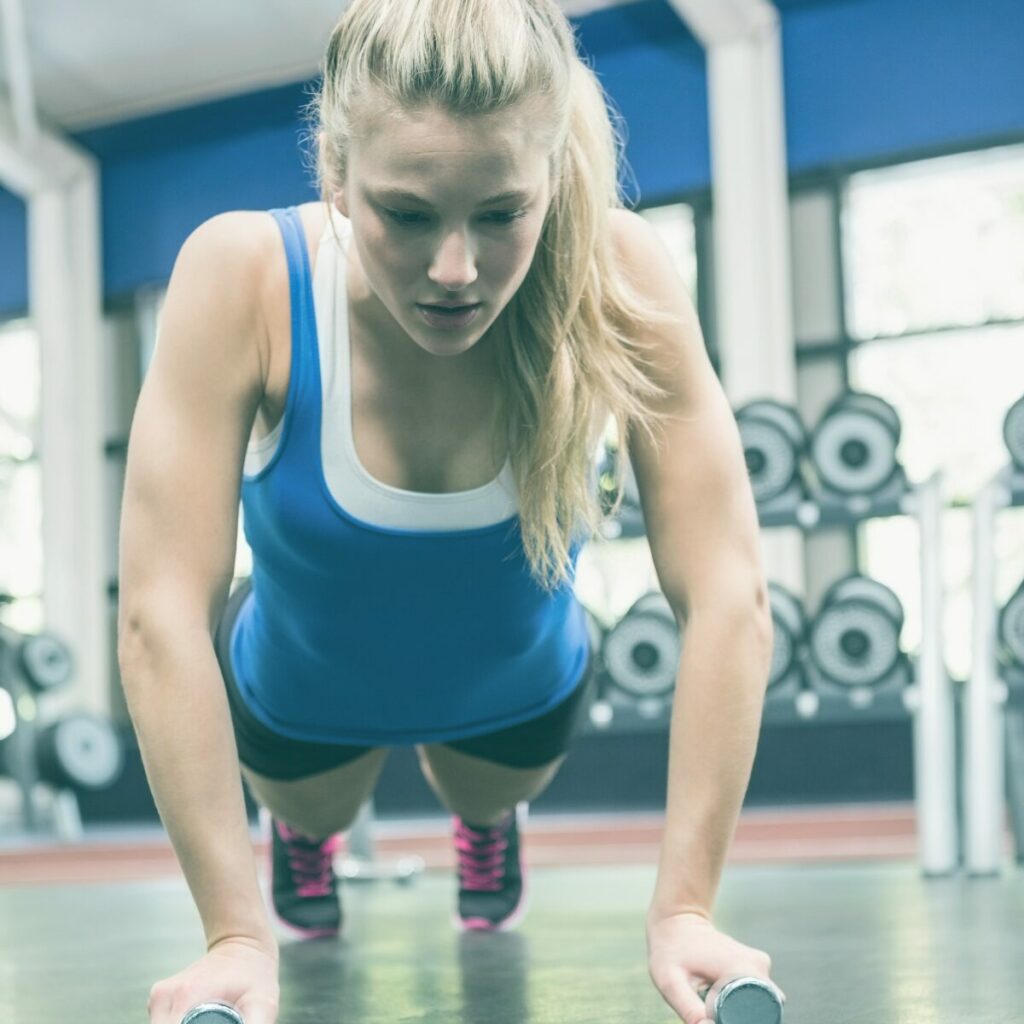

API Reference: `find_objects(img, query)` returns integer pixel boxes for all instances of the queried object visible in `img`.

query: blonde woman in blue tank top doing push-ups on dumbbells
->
[120,0,771,1024]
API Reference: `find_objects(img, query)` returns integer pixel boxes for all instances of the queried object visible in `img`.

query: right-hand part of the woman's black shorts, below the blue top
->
[440,653,595,769]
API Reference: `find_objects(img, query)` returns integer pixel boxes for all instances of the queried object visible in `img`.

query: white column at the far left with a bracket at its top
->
[0,100,111,713]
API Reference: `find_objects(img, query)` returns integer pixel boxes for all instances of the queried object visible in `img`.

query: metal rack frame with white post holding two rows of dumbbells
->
[586,473,961,876]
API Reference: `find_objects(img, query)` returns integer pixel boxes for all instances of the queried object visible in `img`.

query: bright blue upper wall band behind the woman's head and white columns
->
[0,0,1024,316]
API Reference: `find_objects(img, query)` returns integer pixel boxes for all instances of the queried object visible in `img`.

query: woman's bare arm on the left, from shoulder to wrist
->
[118,212,280,953]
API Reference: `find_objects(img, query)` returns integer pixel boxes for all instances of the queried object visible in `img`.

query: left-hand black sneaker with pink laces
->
[270,817,342,939]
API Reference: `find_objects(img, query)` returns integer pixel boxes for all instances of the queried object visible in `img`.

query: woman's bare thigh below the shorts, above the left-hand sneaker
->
[242,749,388,839]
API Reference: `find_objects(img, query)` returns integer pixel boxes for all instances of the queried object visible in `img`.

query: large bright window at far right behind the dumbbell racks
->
[844,147,1024,679]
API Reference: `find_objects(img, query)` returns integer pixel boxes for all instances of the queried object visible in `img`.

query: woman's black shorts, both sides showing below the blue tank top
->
[214,580,594,779]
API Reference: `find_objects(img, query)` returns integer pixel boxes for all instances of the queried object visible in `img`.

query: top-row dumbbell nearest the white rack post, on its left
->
[810,391,903,497]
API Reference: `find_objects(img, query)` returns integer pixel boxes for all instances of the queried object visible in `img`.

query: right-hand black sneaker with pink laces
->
[453,804,526,932]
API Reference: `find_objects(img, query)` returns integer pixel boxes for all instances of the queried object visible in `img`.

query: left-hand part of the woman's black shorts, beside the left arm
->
[214,580,374,782]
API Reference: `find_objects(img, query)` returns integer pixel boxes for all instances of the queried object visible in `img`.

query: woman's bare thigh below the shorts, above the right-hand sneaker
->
[417,743,565,825]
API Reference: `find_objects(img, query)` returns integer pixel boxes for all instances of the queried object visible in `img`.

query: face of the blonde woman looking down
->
[335,99,551,356]
